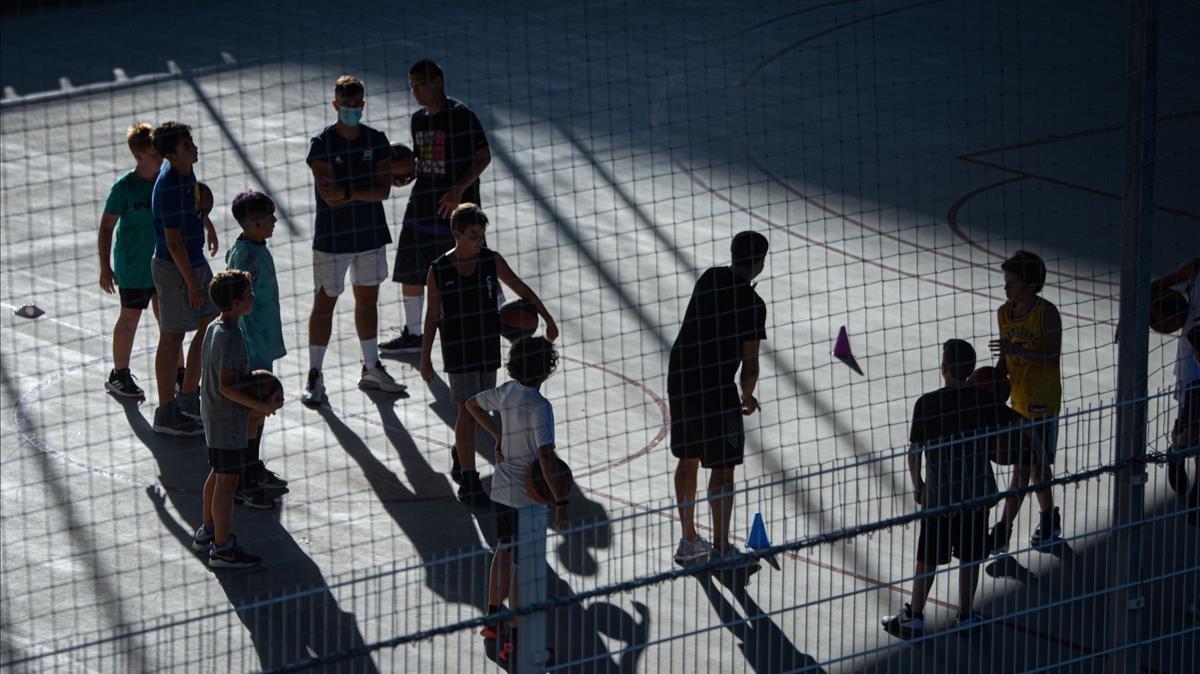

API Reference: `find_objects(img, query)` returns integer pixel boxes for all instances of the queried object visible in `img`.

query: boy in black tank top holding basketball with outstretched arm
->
[420,204,558,507]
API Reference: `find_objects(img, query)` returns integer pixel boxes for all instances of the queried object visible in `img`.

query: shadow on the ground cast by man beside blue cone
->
[696,572,823,674]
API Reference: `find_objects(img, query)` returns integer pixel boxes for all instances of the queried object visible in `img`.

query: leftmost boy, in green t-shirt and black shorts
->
[100,124,162,398]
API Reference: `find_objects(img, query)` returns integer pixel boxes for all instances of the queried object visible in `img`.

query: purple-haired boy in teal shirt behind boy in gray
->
[226,189,288,501]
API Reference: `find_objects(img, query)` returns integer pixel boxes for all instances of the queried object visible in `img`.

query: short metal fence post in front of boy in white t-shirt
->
[514,505,550,674]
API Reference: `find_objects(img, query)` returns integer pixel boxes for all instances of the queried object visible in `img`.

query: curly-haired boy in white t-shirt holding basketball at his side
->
[467,337,570,662]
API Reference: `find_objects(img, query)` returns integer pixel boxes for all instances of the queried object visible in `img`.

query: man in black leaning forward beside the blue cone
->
[667,231,767,565]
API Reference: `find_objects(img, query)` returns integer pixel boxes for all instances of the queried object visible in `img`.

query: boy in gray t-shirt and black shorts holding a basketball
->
[192,270,282,568]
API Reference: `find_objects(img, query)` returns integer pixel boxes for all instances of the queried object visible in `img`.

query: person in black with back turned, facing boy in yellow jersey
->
[883,339,1003,638]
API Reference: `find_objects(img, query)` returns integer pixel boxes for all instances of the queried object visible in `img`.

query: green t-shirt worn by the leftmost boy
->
[104,171,154,288]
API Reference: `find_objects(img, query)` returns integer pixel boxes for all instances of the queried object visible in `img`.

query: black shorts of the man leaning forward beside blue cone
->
[670,395,745,468]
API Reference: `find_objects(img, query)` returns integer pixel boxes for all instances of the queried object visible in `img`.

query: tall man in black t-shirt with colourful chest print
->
[379,59,492,354]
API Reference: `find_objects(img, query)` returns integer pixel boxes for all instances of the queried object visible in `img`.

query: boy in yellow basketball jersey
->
[989,251,1062,552]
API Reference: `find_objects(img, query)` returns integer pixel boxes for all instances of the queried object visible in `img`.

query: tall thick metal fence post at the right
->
[1105,0,1158,674]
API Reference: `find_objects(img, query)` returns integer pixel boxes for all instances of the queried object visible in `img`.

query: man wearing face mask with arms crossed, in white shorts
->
[301,76,404,405]
